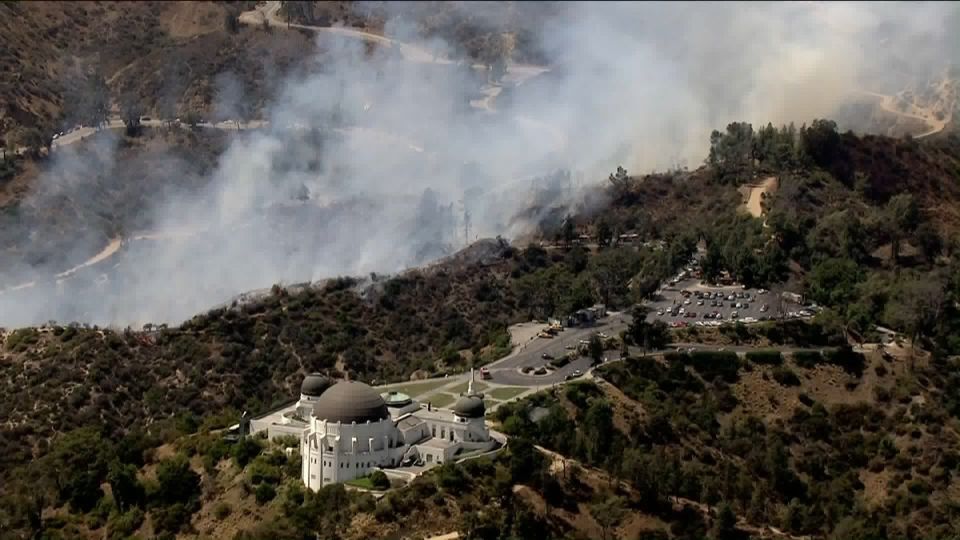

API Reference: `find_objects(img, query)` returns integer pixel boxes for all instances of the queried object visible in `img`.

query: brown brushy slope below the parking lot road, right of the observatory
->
[497,344,958,538]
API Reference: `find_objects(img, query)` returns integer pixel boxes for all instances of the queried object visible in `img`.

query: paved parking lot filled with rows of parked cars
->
[646,279,813,327]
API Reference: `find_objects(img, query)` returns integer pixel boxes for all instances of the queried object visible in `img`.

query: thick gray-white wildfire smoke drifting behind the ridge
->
[0,2,960,326]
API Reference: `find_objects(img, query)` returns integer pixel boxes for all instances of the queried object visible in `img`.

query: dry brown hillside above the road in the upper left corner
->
[0,2,315,139]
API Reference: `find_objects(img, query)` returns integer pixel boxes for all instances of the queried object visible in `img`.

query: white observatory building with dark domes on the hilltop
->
[251,374,497,490]
